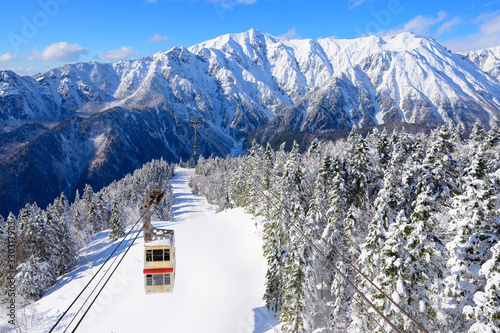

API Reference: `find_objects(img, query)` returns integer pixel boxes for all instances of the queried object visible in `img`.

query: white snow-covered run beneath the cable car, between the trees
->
[0,169,276,333]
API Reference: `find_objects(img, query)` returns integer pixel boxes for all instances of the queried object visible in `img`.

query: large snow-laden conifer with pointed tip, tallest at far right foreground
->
[444,150,499,331]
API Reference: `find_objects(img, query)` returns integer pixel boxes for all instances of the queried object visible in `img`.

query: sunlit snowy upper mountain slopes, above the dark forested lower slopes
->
[0,29,500,132]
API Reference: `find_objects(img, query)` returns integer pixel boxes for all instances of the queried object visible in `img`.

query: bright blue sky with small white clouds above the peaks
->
[0,0,500,75]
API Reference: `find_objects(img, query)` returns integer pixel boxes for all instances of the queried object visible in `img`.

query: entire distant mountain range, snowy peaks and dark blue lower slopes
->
[0,29,500,215]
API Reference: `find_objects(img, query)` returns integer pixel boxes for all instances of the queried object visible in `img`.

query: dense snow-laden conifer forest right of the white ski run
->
[191,122,500,333]
